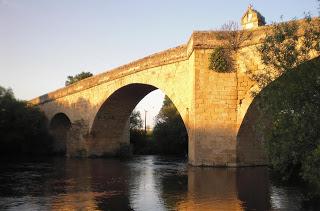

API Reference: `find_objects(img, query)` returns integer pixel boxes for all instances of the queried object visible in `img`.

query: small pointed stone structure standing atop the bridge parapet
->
[241,5,266,29]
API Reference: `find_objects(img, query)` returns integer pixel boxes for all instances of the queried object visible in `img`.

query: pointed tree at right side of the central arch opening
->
[153,96,188,154]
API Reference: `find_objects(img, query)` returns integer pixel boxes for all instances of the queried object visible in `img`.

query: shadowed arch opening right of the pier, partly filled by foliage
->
[237,57,320,165]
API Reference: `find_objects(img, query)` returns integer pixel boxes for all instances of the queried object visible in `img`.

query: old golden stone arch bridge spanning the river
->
[30,9,316,166]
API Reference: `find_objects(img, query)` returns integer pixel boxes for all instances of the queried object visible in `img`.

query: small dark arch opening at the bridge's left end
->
[49,113,71,155]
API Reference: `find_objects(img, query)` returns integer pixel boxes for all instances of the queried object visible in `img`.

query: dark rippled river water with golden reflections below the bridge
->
[0,156,316,210]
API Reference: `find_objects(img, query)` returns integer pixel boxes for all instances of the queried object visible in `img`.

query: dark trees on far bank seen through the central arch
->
[130,96,188,155]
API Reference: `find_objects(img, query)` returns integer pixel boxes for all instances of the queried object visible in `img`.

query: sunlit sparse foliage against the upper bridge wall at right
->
[251,16,320,90]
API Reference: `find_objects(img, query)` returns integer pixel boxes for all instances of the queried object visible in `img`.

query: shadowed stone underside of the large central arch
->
[89,83,188,156]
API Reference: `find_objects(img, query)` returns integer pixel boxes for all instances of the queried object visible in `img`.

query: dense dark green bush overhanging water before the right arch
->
[257,57,320,196]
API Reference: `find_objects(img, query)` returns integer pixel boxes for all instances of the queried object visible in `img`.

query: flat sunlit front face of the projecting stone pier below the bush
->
[191,49,237,166]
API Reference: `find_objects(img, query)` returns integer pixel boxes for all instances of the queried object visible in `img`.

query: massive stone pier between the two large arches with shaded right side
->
[189,49,267,167]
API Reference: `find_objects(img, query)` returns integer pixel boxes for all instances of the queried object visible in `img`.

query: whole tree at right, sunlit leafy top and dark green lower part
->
[251,17,320,198]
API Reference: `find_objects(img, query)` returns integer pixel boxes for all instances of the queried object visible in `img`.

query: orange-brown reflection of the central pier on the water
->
[178,168,241,210]
